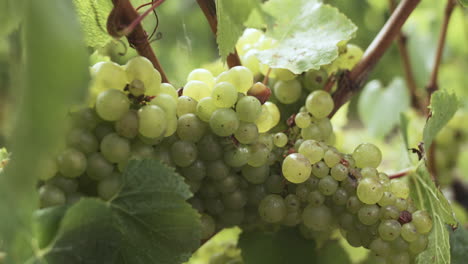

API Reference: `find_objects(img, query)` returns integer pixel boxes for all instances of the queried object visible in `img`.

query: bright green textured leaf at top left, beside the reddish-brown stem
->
[73,0,114,48]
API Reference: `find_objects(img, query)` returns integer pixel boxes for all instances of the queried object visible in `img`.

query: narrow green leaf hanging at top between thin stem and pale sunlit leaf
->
[216,0,258,60]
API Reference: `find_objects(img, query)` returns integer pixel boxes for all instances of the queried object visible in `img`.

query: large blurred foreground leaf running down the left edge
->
[0,0,89,263]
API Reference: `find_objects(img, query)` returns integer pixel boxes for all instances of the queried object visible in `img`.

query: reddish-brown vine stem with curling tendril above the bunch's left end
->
[107,0,169,83]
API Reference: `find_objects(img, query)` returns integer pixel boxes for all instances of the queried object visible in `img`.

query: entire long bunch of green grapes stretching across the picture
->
[33,30,432,264]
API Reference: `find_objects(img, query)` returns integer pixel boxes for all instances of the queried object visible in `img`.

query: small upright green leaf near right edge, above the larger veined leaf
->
[423,90,459,150]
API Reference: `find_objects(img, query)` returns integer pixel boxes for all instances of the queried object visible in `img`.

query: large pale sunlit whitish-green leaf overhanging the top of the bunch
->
[258,0,357,74]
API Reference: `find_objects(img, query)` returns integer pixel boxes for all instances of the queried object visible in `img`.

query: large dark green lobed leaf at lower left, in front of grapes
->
[33,160,201,264]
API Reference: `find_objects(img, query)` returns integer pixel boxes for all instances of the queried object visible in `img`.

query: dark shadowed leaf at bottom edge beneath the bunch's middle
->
[239,228,317,264]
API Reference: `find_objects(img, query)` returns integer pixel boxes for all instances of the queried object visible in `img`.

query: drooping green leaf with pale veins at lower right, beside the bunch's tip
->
[410,163,457,264]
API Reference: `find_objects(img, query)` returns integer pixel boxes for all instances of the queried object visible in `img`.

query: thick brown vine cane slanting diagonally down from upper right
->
[330,0,421,117]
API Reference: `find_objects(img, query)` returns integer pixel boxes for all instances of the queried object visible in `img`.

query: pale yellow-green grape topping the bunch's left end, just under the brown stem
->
[125,56,161,93]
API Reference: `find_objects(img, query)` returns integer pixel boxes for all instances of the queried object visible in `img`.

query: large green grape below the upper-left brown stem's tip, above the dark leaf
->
[138,105,167,138]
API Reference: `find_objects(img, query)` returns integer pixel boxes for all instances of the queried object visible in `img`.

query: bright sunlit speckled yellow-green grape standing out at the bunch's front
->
[282,153,312,183]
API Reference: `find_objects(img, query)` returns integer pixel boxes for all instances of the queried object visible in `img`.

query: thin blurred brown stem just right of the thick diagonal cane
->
[389,0,427,114]
